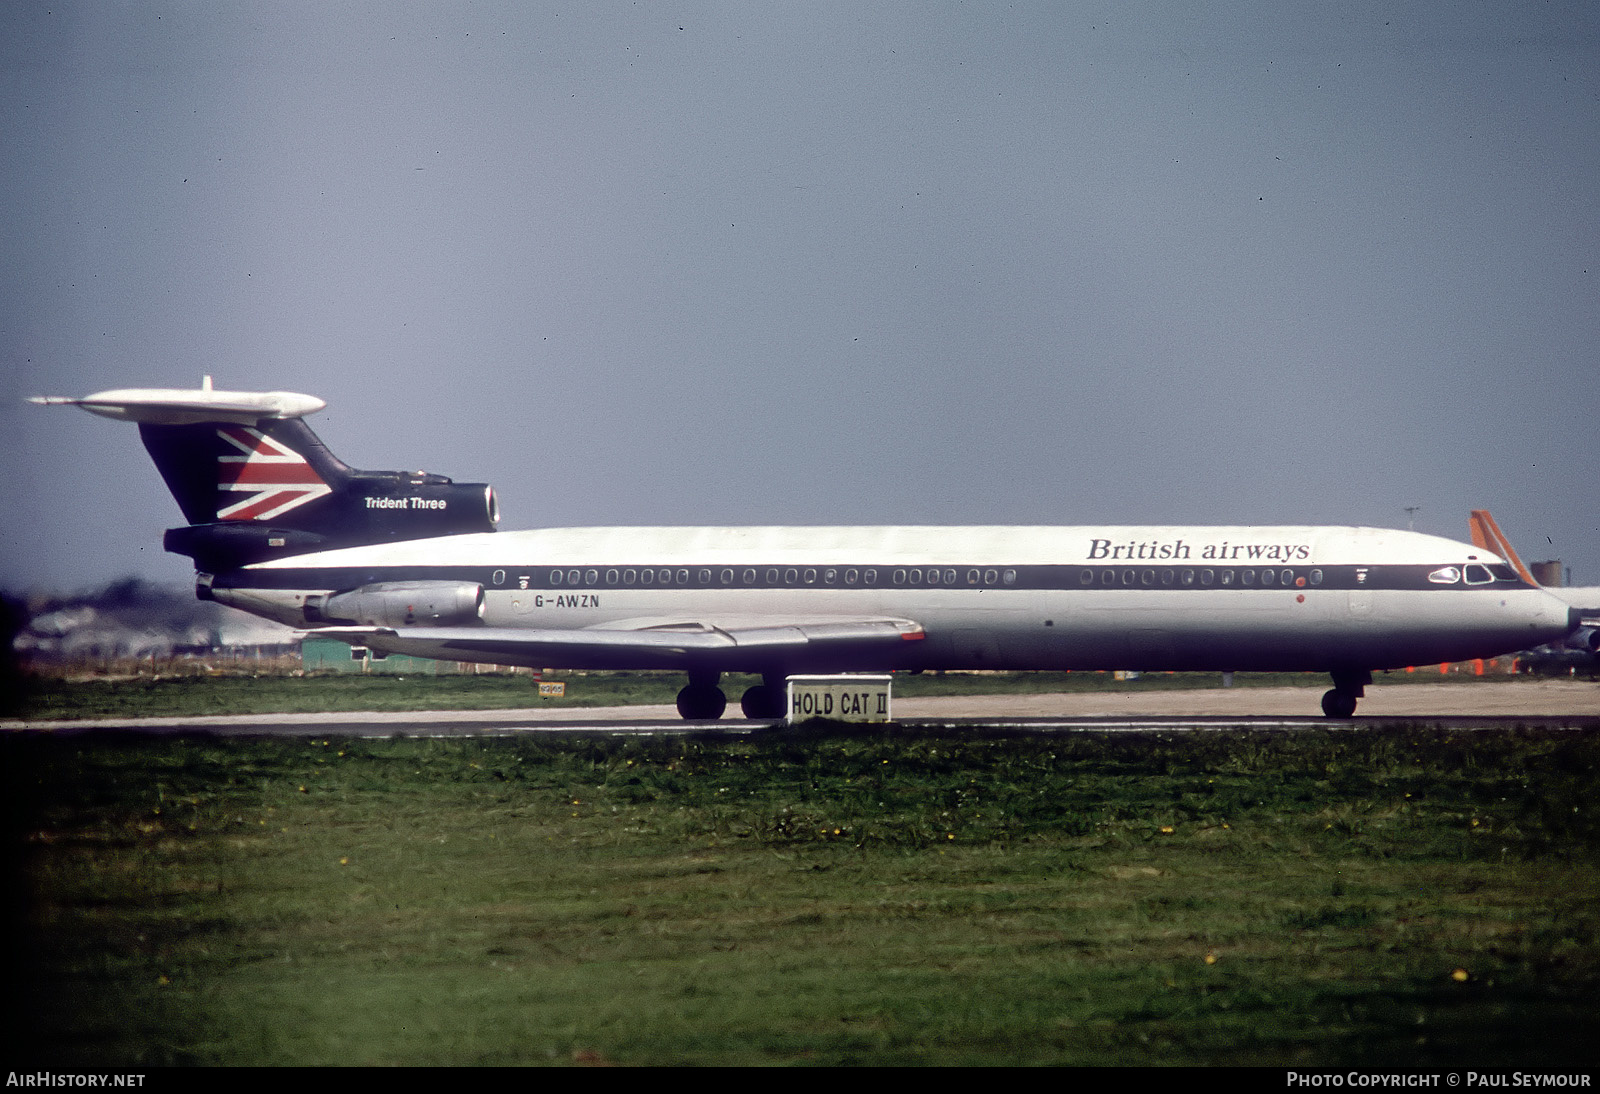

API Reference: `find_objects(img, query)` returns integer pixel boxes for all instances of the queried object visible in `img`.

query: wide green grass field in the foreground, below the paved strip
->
[0,728,1600,1070]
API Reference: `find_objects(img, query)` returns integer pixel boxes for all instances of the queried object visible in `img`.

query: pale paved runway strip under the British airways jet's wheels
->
[0,680,1600,737]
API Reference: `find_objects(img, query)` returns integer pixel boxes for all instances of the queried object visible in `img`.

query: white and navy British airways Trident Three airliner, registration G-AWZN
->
[32,377,1579,720]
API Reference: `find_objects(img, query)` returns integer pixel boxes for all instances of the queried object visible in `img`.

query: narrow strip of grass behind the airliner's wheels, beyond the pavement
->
[12,672,1514,720]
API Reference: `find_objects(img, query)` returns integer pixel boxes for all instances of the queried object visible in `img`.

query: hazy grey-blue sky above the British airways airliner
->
[0,2,1600,589]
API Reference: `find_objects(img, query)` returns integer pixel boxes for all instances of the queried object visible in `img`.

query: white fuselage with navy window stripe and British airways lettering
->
[211,526,1571,672]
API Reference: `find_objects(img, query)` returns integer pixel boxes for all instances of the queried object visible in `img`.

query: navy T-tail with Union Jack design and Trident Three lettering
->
[32,376,499,573]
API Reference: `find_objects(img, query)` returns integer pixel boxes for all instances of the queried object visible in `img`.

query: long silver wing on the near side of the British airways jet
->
[310,617,926,672]
